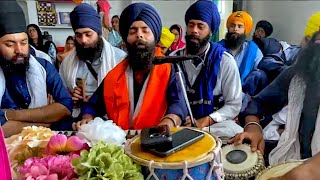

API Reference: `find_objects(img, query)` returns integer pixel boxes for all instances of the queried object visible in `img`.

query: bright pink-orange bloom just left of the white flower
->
[45,134,86,155]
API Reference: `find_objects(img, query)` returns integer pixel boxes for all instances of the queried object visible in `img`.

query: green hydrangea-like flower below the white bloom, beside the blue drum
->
[72,142,143,180]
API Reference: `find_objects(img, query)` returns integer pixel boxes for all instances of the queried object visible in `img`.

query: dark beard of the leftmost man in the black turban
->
[0,53,30,74]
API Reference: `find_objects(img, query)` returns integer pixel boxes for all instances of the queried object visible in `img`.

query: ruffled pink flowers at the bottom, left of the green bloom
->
[20,154,79,180]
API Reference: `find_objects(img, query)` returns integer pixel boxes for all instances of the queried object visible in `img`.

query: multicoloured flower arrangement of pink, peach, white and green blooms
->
[6,119,143,180]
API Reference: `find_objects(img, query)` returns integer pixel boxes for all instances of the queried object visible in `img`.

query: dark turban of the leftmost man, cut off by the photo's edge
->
[0,0,26,38]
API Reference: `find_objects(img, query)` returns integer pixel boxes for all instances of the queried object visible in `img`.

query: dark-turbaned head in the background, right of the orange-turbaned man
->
[252,20,273,41]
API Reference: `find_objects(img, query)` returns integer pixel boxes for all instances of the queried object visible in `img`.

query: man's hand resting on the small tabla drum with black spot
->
[229,125,264,154]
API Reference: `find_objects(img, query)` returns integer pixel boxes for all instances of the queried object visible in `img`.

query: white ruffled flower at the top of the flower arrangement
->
[77,118,126,147]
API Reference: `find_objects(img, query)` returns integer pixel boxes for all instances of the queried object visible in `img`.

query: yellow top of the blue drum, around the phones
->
[130,128,216,163]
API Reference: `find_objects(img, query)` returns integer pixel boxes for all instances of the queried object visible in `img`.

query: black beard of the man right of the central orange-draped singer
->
[185,34,211,55]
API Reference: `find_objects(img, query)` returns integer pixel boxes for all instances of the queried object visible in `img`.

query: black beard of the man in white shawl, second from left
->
[74,38,103,62]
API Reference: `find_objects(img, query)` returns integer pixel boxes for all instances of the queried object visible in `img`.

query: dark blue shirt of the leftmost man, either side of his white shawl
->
[0,58,73,125]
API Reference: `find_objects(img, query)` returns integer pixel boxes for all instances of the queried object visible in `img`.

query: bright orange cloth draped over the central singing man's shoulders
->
[104,47,171,130]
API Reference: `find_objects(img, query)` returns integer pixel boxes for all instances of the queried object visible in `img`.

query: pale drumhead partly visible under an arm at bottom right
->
[256,161,303,180]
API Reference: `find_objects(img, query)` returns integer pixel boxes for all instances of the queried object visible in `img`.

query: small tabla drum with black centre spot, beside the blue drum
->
[222,144,265,180]
